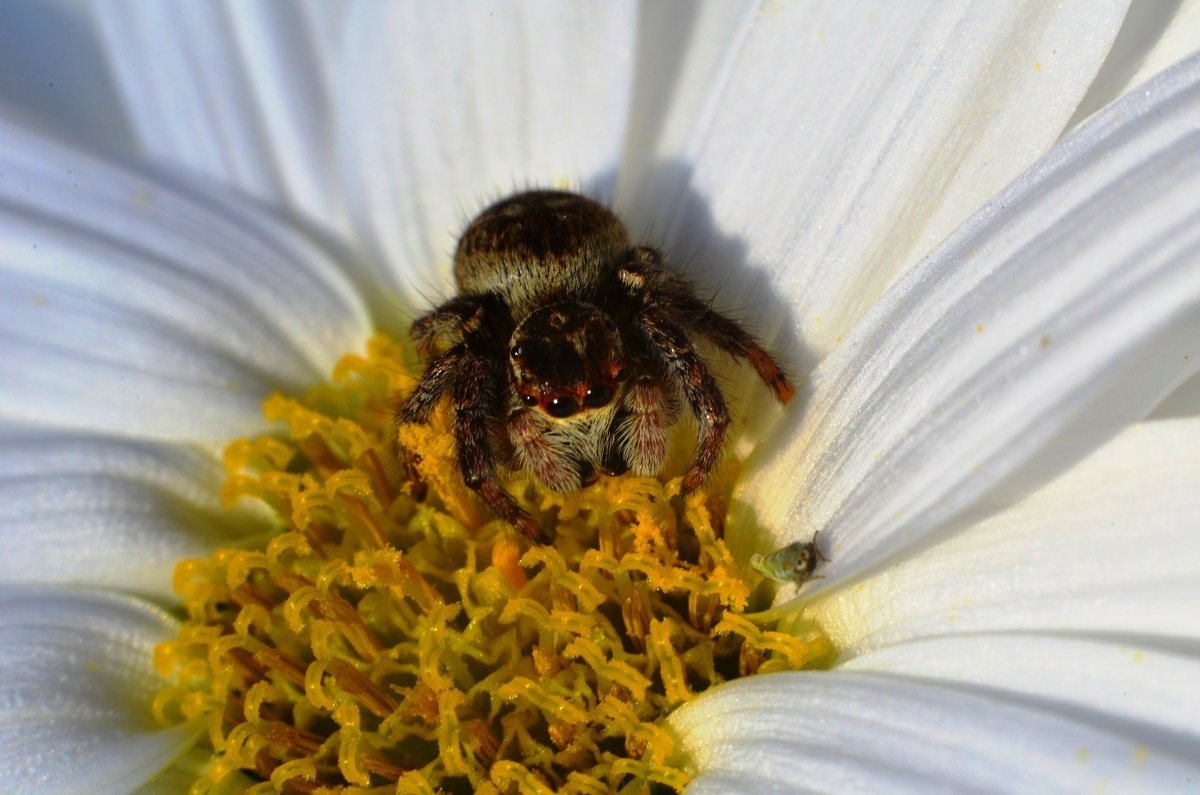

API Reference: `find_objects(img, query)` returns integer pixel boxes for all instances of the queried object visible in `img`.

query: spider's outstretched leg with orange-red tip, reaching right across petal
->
[620,246,796,404]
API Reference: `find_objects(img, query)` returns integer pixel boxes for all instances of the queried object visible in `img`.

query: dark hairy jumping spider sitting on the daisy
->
[398,191,794,542]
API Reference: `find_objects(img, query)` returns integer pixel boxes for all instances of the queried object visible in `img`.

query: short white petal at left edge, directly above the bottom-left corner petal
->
[0,430,269,602]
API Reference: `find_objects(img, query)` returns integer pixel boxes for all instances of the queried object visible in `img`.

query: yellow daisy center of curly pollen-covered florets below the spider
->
[155,337,829,794]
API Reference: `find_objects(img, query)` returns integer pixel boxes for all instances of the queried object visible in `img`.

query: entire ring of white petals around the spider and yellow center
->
[0,0,1200,793]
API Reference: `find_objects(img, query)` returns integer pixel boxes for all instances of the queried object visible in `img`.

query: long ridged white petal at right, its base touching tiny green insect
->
[743,58,1200,585]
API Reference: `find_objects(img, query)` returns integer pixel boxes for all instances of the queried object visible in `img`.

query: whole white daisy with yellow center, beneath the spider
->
[0,1,1200,793]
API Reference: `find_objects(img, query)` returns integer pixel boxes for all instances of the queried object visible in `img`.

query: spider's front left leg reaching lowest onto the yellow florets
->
[454,355,550,544]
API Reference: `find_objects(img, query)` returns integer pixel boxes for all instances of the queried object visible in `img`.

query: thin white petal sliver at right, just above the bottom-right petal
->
[838,633,1200,758]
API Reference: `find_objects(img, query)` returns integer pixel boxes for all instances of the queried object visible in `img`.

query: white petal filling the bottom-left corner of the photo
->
[0,588,196,795]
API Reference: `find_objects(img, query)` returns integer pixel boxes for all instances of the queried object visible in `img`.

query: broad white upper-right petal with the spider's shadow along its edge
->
[660,0,1127,366]
